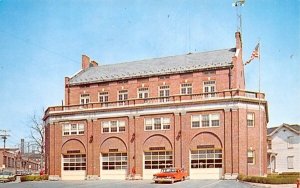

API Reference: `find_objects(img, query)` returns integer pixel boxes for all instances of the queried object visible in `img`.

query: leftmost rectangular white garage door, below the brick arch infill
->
[61,154,86,180]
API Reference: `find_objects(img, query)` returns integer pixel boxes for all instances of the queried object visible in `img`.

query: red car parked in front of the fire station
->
[153,168,187,183]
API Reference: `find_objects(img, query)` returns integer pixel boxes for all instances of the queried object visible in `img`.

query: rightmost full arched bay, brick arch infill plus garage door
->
[189,133,223,179]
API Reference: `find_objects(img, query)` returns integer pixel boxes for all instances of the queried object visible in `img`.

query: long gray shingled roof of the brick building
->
[70,48,236,85]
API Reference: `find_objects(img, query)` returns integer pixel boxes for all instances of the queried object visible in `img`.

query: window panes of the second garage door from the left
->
[102,153,127,170]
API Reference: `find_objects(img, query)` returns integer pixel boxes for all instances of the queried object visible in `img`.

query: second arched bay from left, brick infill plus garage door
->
[100,137,128,179]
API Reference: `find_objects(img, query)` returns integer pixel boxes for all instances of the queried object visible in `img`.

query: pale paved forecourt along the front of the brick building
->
[0,180,258,188]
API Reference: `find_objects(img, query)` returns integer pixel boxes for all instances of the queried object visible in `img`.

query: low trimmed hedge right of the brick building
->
[238,174,299,184]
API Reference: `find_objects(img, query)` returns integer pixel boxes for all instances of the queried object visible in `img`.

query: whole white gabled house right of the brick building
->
[268,124,300,173]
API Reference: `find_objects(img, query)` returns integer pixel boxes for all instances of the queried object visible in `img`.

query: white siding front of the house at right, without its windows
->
[271,127,300,173]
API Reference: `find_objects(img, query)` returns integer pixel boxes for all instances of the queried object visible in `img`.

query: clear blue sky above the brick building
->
[0,0,300,147]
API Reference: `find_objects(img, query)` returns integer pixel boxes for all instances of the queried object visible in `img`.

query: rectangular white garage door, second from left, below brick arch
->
[100,153,127,179]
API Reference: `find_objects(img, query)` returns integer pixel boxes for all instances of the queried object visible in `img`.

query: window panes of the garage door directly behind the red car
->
[144,150,173,169]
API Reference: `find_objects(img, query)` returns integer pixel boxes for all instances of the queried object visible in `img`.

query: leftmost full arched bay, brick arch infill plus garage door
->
[61,140,86,180]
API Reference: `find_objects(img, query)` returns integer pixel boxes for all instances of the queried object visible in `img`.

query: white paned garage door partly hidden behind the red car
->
[143,151,173,179]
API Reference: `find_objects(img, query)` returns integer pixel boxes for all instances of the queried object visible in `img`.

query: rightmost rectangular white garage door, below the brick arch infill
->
[190,149,223,179]
